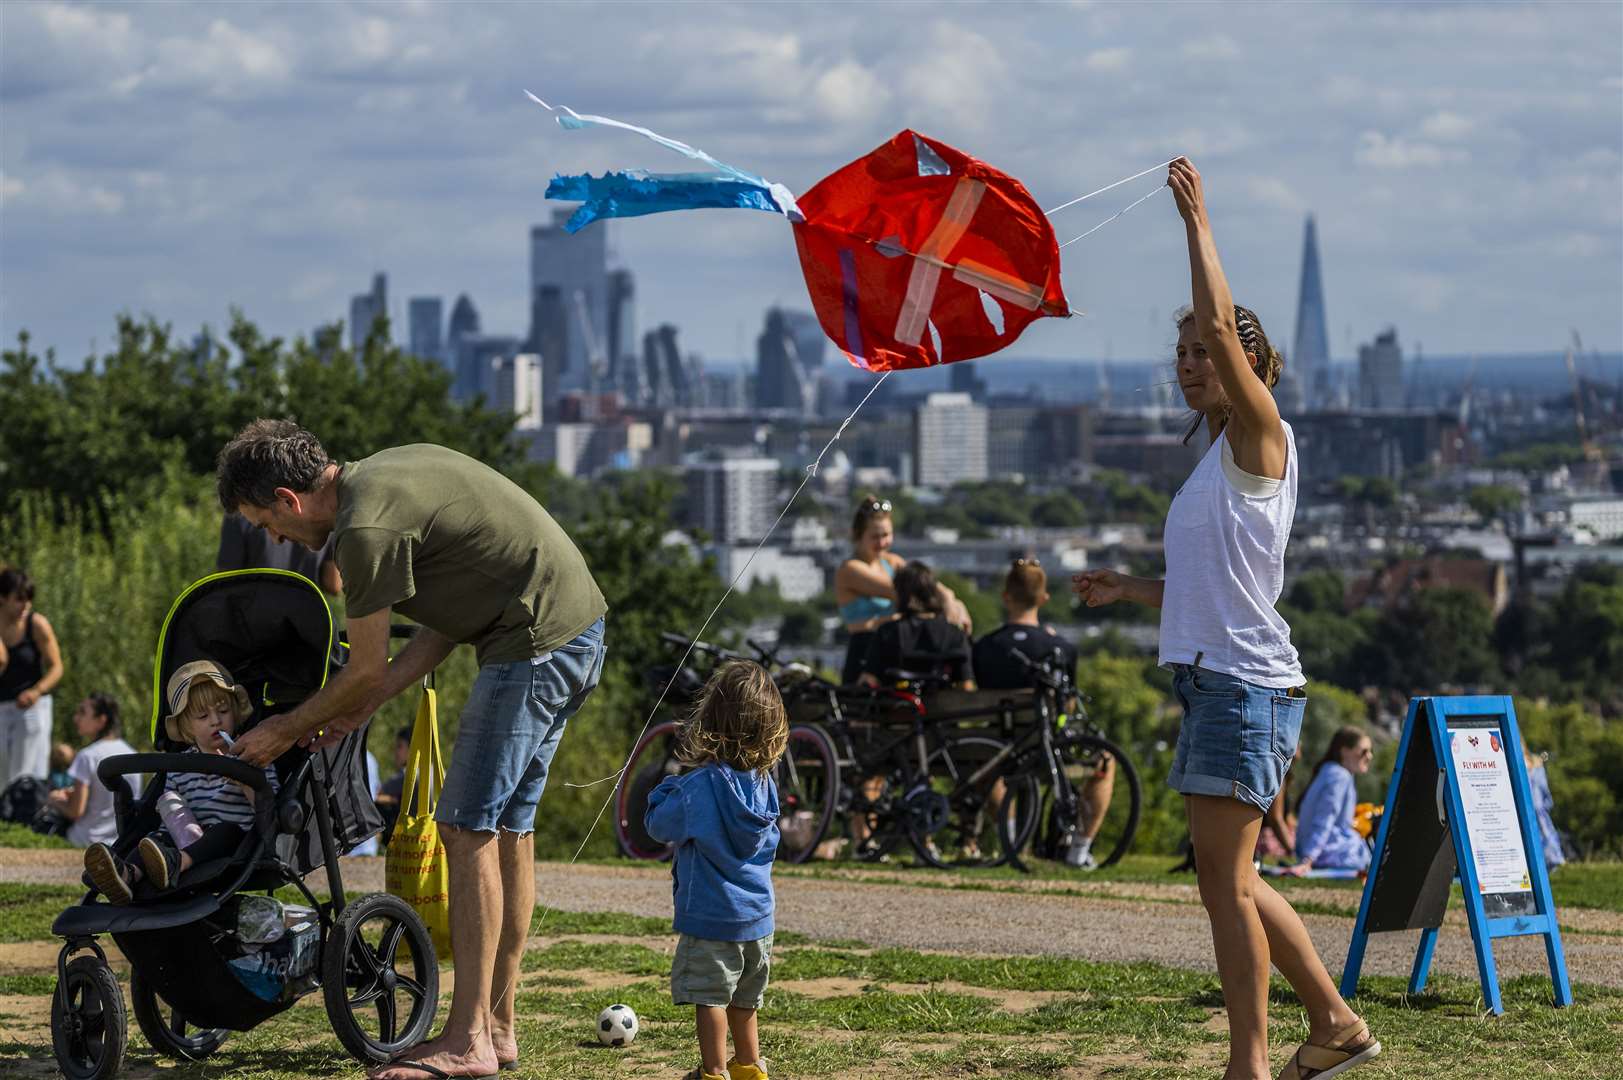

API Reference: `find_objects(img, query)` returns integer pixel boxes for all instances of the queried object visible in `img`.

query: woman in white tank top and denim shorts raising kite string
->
[1073,158,1381,1080]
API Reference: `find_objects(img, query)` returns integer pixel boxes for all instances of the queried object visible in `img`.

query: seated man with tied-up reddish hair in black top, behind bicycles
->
[975,559,1115,870]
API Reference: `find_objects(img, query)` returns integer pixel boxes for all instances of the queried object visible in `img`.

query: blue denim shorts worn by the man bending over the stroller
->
[433,619,604,833]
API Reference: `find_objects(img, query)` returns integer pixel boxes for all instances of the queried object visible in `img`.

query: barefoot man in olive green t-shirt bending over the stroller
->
[217,421,607,1080]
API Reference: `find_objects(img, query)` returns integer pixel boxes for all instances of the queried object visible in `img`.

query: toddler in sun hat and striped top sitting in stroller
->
[84,659,279,903]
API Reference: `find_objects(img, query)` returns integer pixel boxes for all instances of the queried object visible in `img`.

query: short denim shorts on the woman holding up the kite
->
[1167,664,1308,812]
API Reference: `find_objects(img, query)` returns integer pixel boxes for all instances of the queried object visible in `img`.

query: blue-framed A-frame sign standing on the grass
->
[1341,697,1573,1013]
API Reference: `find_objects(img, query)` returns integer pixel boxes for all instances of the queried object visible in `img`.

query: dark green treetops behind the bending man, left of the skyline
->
[0,312,523,526]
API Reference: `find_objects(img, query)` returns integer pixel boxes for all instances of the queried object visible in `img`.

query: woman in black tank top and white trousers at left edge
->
[0,567,62,789]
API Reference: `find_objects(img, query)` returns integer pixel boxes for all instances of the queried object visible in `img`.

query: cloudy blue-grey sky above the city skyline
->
[0,0,1623,370]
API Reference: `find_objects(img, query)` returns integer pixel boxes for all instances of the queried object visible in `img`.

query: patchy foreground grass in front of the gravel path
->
[0,883,1623,1080]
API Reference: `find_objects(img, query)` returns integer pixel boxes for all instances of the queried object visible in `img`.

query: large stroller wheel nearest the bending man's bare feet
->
[321,893,440,1064]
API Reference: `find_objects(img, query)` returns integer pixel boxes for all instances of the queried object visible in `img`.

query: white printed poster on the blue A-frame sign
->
[1448,728,1532,895]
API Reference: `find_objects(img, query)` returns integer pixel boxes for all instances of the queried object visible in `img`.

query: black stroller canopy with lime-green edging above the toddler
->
[153,570,334,750]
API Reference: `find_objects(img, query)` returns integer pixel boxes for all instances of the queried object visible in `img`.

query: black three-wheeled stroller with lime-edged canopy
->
[50,570,440,1080]
